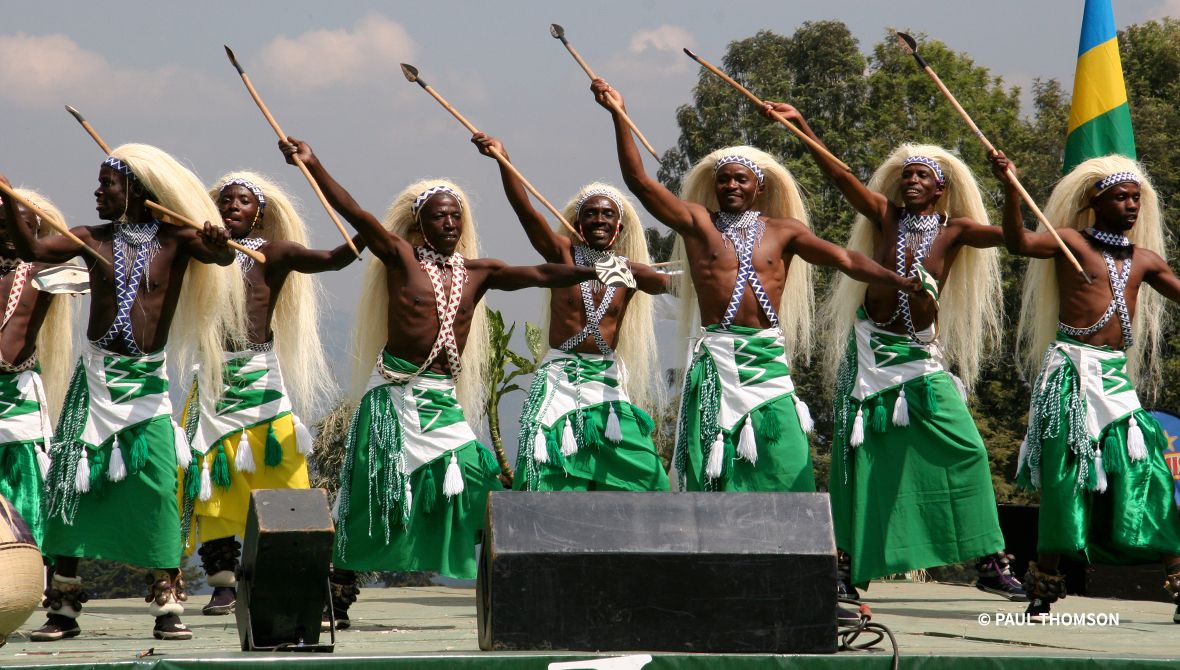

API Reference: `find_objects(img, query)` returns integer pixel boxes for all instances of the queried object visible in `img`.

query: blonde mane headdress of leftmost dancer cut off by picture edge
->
[13,189,81,423]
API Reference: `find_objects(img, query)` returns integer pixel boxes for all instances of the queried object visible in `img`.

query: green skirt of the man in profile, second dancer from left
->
[41,416,183,567]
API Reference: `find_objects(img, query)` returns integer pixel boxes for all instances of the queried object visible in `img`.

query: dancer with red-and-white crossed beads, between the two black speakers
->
[280,138,618,628]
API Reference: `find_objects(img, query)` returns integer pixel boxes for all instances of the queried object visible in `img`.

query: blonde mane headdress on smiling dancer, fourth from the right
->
[542,182,663,412]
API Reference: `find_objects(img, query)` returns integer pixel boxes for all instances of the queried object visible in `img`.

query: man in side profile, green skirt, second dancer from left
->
[8,144,244,642]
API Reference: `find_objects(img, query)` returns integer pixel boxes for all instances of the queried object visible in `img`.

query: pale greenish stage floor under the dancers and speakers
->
[0,582,1180,670]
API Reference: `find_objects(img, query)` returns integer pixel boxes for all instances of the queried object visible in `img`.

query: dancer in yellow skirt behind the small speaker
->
[181,172,363,616]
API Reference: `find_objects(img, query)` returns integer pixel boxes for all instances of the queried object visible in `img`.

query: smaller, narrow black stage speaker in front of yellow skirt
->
[235,488,336,651]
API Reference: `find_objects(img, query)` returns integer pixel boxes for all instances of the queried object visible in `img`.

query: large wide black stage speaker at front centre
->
[477,491,837,653]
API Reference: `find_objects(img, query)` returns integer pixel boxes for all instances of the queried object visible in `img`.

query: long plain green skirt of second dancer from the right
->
[828,373,1004,587]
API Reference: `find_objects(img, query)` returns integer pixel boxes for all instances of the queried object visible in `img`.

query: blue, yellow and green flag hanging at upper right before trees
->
[1062,0,1135,175]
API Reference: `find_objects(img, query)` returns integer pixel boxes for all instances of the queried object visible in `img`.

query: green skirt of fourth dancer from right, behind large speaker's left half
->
[512,402,668,491]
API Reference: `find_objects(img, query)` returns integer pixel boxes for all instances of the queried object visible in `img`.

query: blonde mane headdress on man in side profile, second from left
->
[111,144,245,395]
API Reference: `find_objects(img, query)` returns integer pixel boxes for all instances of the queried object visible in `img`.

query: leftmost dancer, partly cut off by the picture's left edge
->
[0,187,76,549]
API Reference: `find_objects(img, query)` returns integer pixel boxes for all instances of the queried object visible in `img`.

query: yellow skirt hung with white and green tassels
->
[177,414,310,556]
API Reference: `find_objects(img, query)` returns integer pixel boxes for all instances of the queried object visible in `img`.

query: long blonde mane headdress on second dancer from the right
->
[822,144,1003,389]
